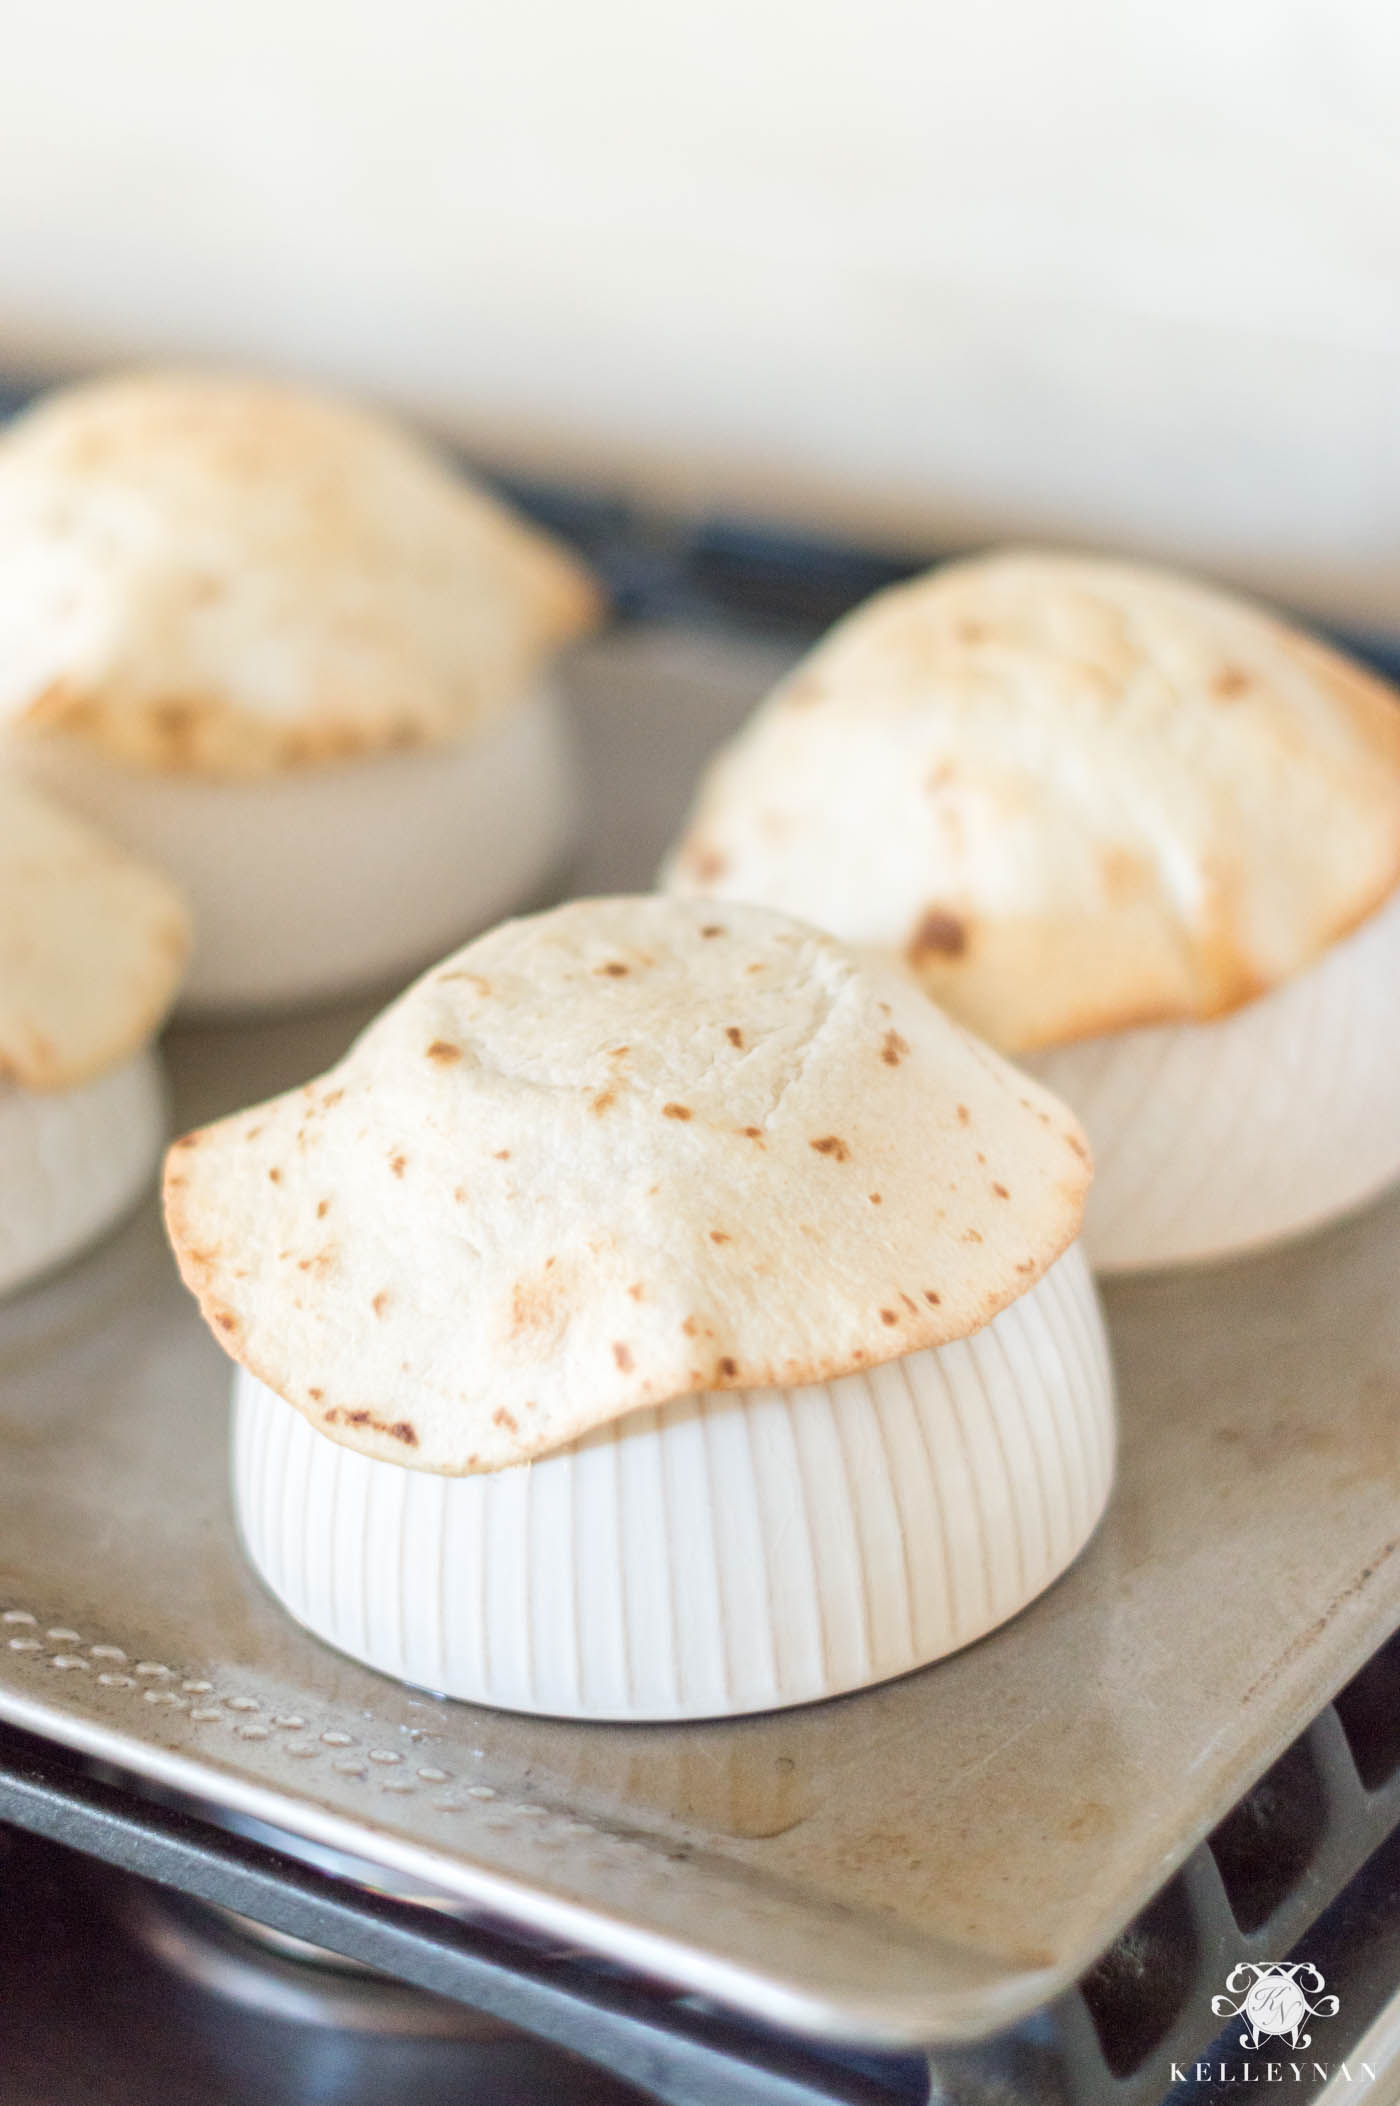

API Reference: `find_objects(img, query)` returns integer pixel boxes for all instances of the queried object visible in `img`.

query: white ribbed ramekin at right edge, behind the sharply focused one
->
[1021,871,1400,1272]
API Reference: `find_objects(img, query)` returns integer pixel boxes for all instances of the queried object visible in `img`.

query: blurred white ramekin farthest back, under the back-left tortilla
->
[13,684,575,1015]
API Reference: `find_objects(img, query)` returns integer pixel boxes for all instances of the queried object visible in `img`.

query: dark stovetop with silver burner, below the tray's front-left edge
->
[0,1828,644,2106]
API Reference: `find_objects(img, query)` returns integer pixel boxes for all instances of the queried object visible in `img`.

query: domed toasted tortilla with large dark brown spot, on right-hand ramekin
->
[665,554,1400,1053]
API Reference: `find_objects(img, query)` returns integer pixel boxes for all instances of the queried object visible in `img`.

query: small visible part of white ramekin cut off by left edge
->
[0,1049,166,1295]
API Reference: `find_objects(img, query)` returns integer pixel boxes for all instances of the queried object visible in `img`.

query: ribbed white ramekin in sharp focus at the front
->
[234,1245,1114,1721]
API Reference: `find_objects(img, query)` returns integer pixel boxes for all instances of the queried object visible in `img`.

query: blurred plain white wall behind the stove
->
[0,0,1400,625]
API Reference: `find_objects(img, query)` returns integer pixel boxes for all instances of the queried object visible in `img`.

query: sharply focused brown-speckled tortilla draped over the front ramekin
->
[166,897,1091,1474]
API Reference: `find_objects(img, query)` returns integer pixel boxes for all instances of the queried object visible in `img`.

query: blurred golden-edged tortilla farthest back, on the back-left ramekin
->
[0,373,600,777]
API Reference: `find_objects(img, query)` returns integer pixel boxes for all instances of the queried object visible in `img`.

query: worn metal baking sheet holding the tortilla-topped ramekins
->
[0,628,1400,2045]
